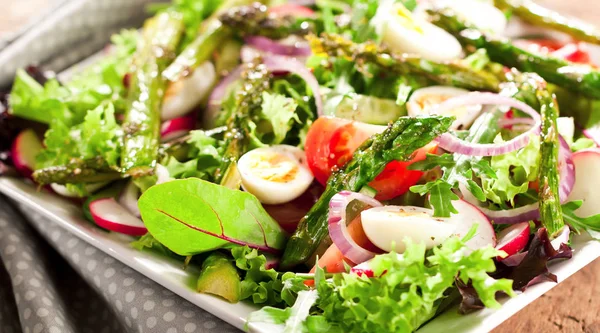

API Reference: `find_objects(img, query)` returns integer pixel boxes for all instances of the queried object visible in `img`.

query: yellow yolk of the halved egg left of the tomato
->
[249,153,298,183]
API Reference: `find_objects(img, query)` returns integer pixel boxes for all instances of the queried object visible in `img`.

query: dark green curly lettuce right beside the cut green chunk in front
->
[231,246,308,306]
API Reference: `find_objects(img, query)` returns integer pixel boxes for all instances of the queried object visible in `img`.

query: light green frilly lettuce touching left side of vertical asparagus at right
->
[481,135,540,206]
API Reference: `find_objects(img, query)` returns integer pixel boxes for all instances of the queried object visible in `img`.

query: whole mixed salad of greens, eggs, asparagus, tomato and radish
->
[0,0,600,332]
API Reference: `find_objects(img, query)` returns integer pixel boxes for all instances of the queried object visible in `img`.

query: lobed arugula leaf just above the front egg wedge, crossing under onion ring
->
[410,110,503,217]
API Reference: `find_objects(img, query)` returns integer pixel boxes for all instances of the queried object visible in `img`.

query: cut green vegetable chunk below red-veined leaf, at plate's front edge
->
[196,252,242,303]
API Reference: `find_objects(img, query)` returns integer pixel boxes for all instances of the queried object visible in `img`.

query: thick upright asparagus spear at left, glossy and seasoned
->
[121,11,184,178]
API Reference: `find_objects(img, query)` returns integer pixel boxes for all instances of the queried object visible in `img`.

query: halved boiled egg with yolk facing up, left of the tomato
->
[237,145,314,205]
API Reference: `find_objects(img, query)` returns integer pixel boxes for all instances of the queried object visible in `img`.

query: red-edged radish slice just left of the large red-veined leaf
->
[90,198,148,236]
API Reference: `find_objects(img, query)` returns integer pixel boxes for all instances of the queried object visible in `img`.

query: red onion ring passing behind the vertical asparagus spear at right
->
[459,136,575,224]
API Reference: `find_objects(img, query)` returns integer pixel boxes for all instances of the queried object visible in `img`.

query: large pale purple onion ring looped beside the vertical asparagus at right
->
[431,92,542,156]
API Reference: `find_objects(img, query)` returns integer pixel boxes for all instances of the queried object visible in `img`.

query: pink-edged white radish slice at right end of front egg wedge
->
[451,200,496,250]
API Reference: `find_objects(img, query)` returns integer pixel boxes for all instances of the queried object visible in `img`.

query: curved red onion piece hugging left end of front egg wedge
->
[327,191,382,264]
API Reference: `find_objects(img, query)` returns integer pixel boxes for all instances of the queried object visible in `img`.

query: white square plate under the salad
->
[0,177,600,333]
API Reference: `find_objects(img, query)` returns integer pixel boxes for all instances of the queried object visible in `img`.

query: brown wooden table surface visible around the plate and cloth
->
[0,0,600,333]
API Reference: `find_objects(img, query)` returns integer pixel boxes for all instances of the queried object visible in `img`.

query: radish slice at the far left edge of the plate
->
[11,129,43,178]
